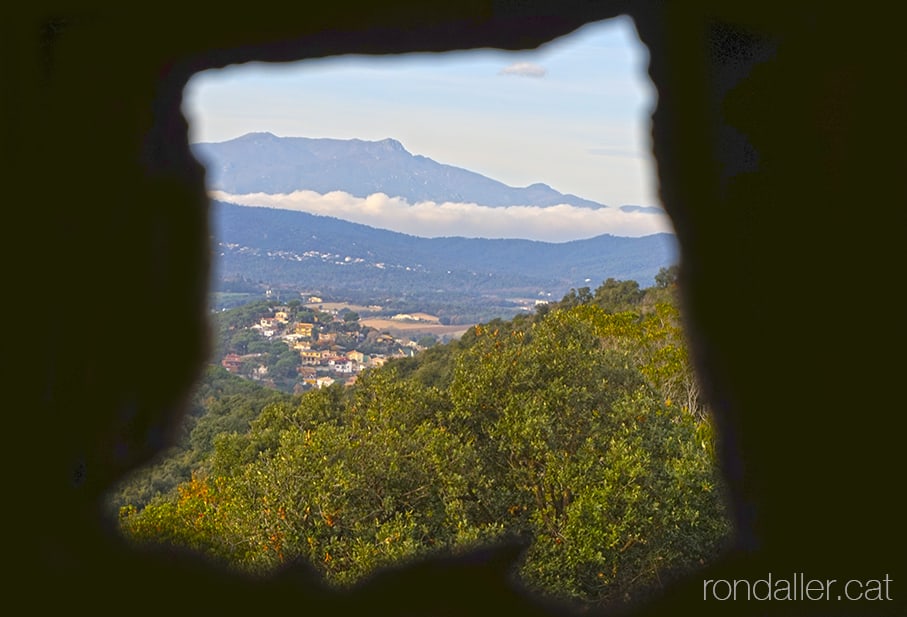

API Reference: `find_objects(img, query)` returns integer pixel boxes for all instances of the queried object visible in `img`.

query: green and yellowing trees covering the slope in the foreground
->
[110,270,731,607]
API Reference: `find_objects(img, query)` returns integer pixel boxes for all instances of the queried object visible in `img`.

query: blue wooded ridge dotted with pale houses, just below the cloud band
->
[212,202,677,297]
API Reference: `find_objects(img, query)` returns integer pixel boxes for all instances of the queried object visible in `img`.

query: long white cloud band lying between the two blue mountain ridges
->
[209,191,673,242]
